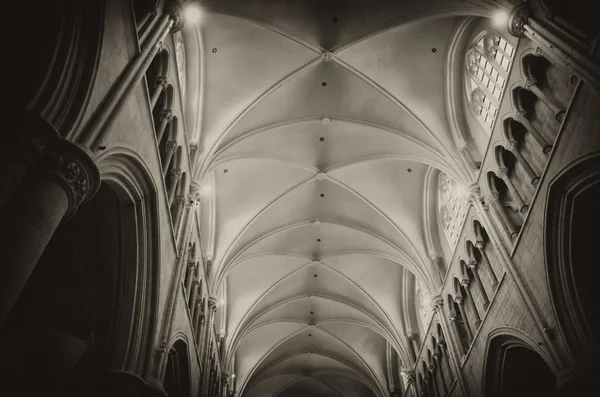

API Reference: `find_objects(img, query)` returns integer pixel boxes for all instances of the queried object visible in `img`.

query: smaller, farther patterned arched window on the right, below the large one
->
[438,173,468,249]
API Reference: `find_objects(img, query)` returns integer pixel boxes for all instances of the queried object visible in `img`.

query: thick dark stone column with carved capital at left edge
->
[0,116,100,328]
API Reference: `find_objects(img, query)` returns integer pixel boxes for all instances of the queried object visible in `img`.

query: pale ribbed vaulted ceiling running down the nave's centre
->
[186,0,502,397]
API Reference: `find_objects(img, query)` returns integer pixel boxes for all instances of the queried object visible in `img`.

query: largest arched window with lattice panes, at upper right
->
[465,31,515,132]
